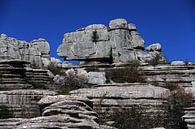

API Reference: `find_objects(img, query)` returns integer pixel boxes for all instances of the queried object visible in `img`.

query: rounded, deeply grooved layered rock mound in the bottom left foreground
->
[17,95,114,129]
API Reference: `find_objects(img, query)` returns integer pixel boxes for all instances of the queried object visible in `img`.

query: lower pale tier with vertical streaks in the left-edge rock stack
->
[0,90,56,118]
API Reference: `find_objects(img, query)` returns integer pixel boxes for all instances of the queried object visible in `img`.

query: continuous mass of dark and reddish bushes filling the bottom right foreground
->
[100,86,193,129]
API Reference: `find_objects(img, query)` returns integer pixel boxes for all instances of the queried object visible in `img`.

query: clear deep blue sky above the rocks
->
[0,0,195,61]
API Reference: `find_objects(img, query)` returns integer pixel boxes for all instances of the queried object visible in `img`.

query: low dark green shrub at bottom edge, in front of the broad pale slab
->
[111,106,166,129]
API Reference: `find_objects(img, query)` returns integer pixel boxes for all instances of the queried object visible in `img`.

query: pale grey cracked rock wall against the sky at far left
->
[0,34,50,67]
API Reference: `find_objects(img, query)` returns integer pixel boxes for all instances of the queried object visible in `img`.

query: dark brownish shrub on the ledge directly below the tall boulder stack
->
[106,62,145,83]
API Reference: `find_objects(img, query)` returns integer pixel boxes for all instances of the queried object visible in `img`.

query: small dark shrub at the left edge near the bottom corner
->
[0,105,13,119]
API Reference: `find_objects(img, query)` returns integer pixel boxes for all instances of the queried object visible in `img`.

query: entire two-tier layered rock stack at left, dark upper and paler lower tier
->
[0,57,56,117]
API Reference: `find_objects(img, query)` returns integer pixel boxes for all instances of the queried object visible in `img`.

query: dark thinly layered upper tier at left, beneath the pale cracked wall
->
[0,59,50,90]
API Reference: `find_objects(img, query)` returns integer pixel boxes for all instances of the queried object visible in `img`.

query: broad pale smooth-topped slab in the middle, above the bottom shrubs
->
[70,83,170,118]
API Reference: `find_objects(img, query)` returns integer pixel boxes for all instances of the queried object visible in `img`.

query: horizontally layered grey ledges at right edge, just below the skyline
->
[141,62,195,88]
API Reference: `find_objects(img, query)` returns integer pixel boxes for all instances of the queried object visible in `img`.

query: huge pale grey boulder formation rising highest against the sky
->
[57,19,165,63]
